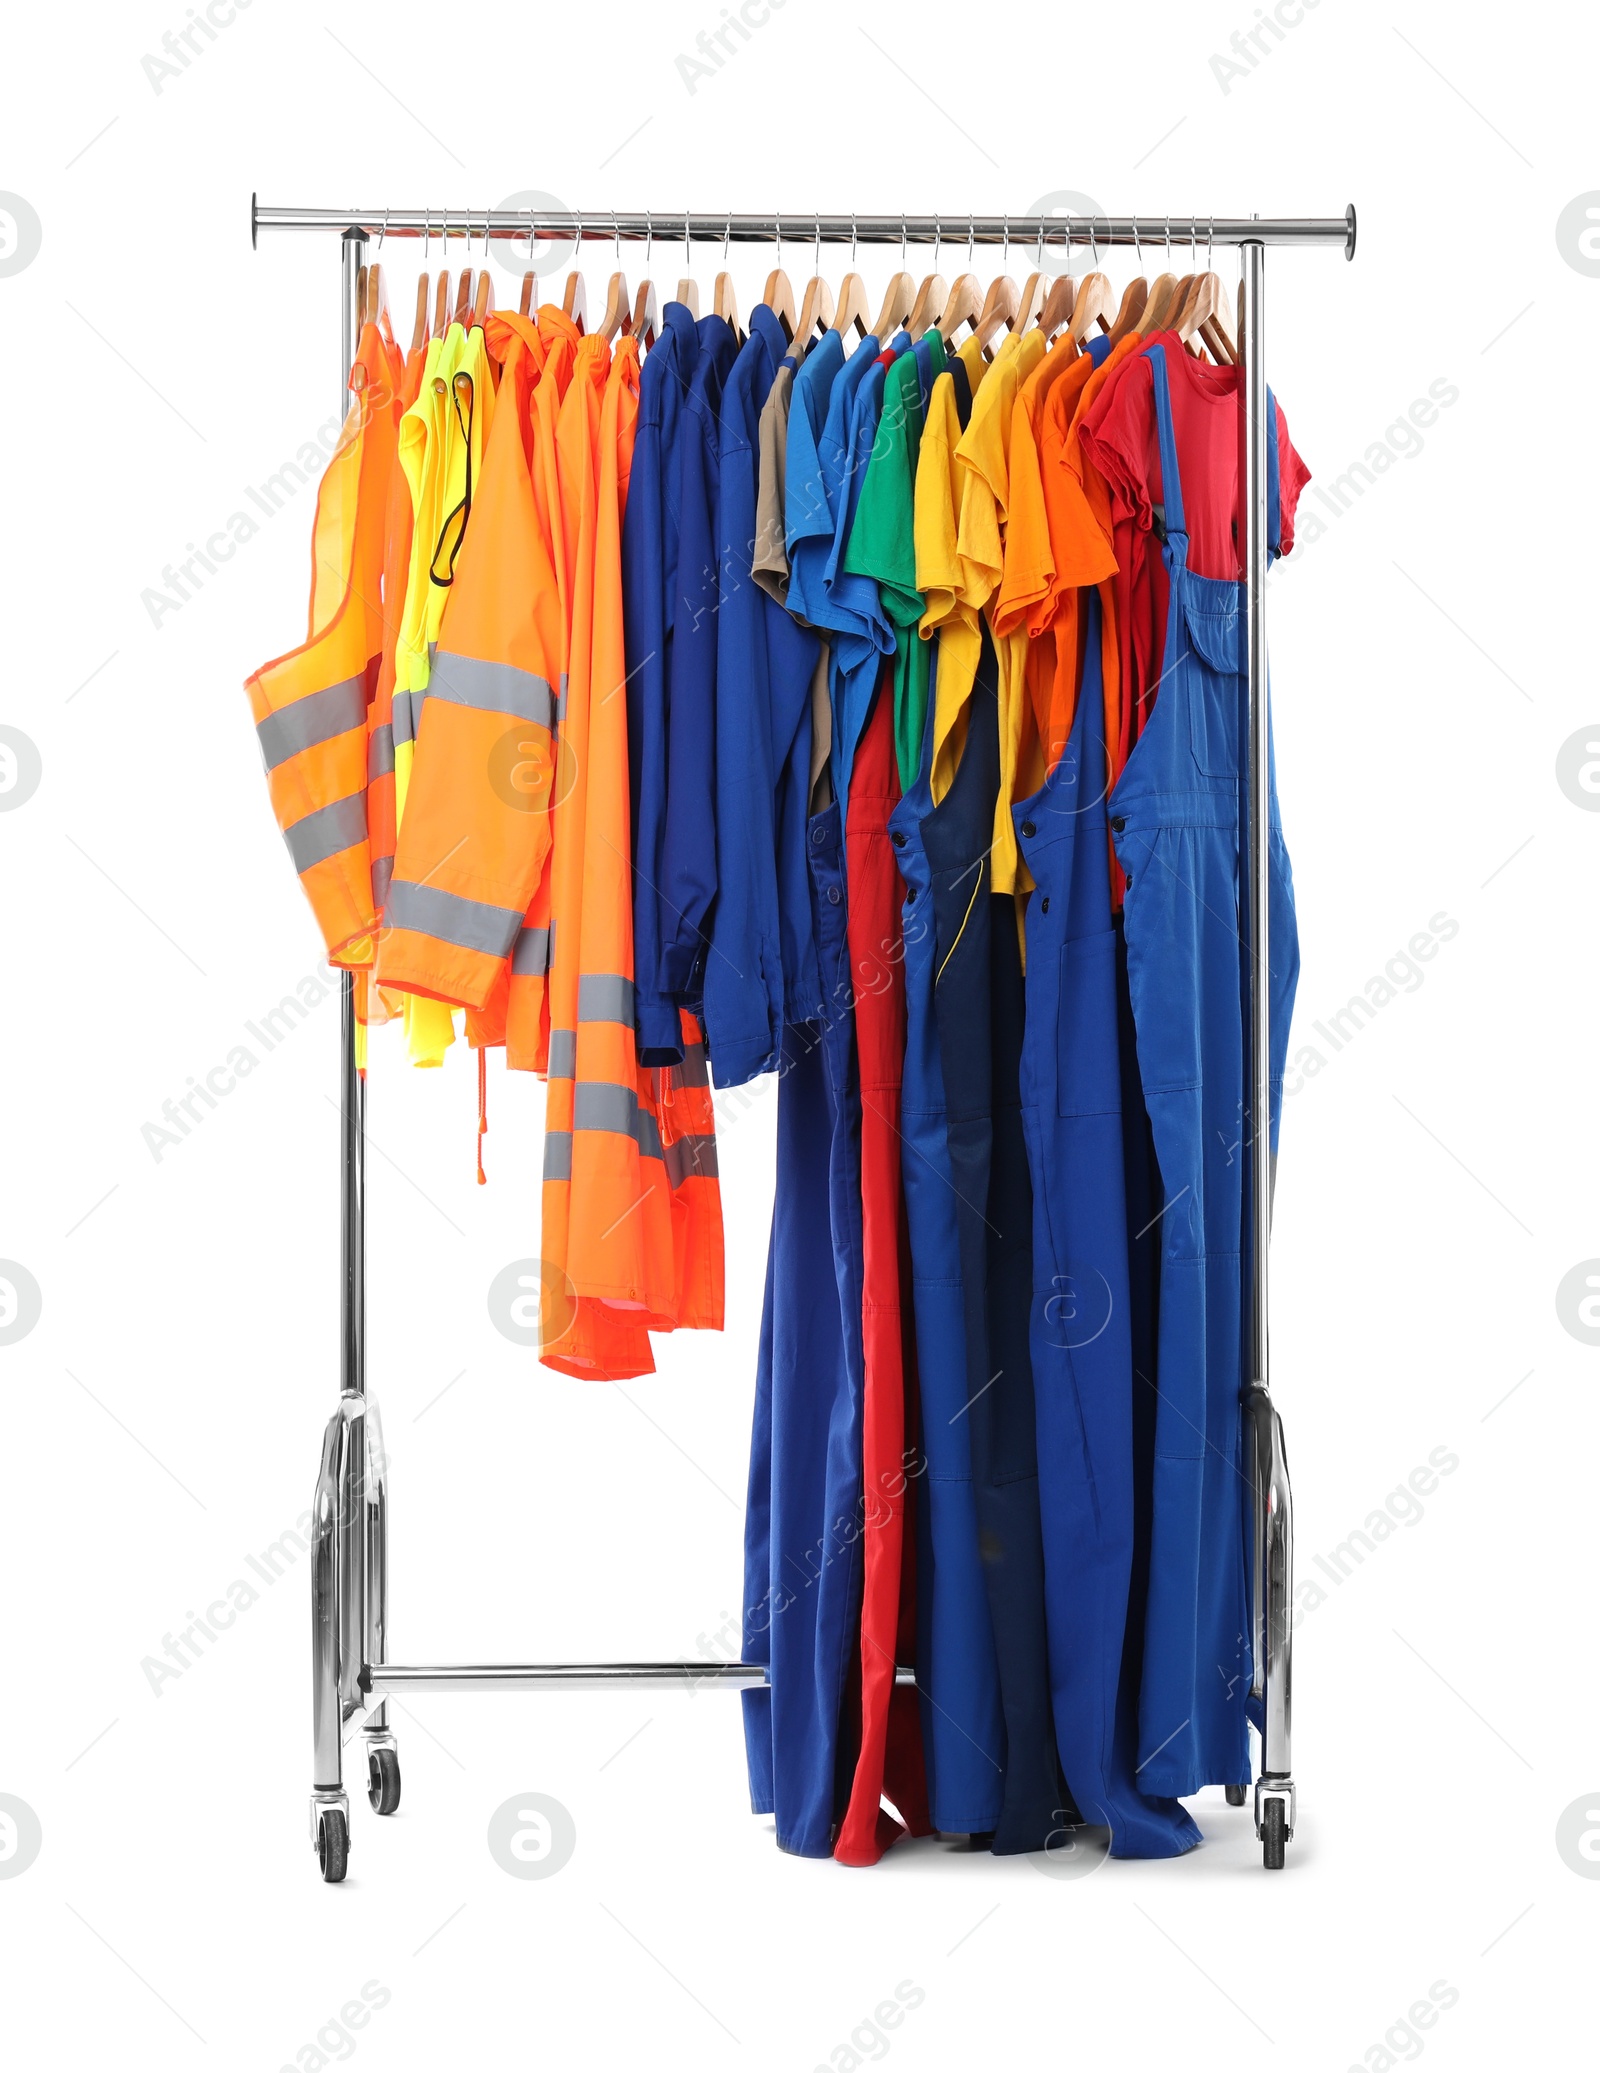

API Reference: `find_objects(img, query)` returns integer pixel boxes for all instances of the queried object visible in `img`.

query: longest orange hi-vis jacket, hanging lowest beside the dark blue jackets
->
[541,338,723,1379]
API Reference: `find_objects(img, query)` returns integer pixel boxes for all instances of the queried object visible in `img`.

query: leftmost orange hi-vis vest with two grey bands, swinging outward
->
[245,323,400,966]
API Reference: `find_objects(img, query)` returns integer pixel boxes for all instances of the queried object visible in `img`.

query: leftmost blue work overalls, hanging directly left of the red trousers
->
[744,804,862,1857]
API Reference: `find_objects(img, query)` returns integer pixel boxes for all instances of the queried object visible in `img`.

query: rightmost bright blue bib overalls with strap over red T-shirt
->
[1111,348,1299,1793]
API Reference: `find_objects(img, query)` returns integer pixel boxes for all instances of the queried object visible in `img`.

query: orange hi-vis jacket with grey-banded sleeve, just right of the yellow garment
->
[377,319,562,1010]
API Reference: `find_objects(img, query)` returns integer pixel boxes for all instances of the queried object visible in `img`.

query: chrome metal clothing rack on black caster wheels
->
[251,195,1355,1882]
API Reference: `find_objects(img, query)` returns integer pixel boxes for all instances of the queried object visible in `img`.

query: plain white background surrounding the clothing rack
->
[0,0,1600,2073]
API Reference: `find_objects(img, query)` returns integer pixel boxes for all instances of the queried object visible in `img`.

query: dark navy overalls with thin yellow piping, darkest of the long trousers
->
[922,628,1076,1855]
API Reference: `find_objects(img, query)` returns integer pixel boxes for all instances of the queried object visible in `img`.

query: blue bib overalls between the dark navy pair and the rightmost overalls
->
[1011,591,1200,1857]
